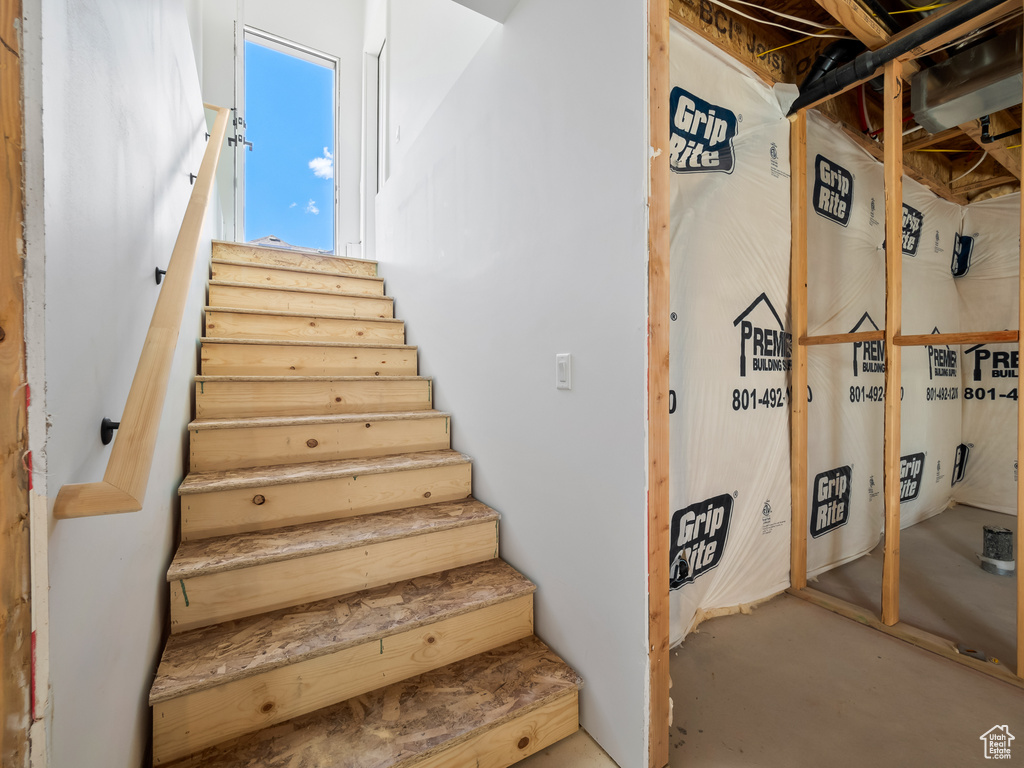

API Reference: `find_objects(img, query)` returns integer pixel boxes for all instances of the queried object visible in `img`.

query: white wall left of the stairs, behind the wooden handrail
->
[27,0,217,768]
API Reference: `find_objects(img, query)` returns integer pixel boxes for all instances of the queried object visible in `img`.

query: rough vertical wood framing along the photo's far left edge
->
[0,0,32,768]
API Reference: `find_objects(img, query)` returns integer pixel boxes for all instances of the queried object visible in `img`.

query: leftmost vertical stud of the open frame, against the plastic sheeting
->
[790,110,807,589]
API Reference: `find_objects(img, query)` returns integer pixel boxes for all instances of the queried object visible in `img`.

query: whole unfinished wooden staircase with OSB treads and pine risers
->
[150,243,581,768]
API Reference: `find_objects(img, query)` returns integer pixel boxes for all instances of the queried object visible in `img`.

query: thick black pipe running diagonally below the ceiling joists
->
[790,0,1004,115]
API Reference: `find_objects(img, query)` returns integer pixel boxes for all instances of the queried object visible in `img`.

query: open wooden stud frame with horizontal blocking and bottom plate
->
[790,7,1024,687]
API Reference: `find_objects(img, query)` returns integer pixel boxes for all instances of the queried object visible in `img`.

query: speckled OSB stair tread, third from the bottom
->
[167,498,499,582]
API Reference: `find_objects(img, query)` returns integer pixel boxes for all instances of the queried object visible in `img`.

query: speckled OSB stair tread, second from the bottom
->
[150,558,537,705]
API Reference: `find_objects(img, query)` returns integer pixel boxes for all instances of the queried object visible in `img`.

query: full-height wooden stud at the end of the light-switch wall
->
[647,0,672,768]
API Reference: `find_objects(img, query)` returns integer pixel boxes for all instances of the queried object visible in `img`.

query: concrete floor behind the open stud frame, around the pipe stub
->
[811,506,1024,663]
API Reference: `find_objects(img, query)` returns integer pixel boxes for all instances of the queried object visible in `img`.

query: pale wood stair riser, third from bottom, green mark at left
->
[170,523,498,634]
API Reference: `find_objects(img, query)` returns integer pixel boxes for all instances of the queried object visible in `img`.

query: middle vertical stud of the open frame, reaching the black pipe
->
[882,60,903,627]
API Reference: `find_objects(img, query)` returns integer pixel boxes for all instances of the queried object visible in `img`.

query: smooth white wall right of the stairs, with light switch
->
[377,0,648,768]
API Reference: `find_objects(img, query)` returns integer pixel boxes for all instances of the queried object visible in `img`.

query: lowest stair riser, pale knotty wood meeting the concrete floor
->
[409,690,580,768]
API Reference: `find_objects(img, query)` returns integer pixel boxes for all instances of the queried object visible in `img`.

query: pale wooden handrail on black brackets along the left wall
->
[53,104,229,518]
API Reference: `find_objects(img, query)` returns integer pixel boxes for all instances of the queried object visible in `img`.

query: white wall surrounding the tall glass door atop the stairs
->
[203,0,365,251]
